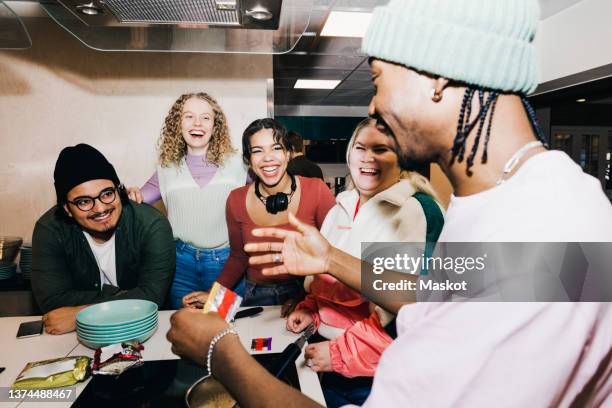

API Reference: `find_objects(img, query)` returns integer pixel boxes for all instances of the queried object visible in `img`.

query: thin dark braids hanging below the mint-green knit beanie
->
[450,86,548,172]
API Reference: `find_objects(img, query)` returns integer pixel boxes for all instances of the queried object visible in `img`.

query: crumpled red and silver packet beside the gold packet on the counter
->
[92,341,144,375]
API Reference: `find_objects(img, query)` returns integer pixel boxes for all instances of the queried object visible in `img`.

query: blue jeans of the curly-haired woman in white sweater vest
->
[170,239,244,309]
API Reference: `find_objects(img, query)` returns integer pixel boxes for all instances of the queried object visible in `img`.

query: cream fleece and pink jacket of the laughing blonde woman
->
[298,180,436,377]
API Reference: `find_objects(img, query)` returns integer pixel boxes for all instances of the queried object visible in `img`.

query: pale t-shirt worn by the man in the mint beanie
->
[364,151,612,407]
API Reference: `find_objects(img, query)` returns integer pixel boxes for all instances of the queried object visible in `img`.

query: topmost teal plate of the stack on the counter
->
[77,299,157,327]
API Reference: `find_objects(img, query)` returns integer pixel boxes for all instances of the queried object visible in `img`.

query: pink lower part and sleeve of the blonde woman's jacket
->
[298,274,393,377]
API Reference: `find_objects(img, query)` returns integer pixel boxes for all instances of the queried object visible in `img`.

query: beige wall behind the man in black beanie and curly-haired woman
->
[0,19,272,240]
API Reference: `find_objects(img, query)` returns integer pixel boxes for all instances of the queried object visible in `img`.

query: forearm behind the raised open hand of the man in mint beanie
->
[328,247,416,314]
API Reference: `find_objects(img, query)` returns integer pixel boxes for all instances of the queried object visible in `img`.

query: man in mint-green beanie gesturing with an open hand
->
[168,0,612,407]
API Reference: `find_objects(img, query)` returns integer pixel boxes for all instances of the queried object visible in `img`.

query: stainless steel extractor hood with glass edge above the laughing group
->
[40,0,313,54]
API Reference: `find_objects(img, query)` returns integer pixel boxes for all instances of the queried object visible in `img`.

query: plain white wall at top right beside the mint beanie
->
[536,0,612,82]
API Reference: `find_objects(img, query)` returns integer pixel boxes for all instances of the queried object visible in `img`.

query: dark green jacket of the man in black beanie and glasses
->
[32,202,176,313]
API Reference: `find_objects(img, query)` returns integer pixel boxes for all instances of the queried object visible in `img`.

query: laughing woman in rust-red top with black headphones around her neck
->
[184,118,335,308]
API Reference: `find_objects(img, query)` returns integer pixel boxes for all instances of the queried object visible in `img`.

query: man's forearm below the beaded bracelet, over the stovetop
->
[212,336,320,408]
